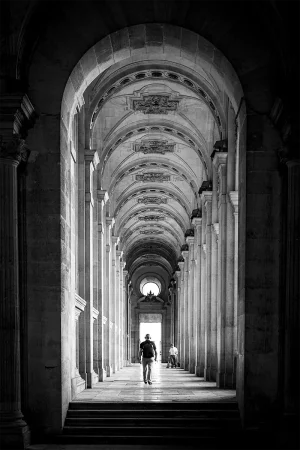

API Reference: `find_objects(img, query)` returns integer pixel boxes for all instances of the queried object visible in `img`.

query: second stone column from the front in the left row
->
[97,189,108,381]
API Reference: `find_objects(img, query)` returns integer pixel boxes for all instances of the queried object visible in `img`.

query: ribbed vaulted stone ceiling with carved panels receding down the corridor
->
[85,58,226,275]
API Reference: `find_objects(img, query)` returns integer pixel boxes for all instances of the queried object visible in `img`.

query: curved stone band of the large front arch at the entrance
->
[62,24,243,139]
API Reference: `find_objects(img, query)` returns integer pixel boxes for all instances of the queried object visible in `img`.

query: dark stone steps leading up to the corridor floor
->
[59,402,241,448]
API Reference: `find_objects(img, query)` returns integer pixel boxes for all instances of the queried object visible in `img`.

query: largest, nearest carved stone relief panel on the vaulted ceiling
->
[132,95,179,114]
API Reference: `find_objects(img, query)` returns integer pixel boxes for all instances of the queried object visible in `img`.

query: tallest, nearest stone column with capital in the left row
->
[84,150,99,388]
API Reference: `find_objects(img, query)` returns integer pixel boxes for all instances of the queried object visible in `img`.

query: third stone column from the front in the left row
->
[104,217,114,377]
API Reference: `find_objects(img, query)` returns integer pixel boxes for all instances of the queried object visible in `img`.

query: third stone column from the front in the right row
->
[192,217,205,377]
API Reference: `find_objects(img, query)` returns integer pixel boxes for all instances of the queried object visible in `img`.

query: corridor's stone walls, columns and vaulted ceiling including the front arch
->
[61,24,245,393]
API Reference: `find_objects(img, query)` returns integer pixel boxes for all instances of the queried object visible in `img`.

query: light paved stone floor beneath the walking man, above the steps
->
[74,363,236,403]
